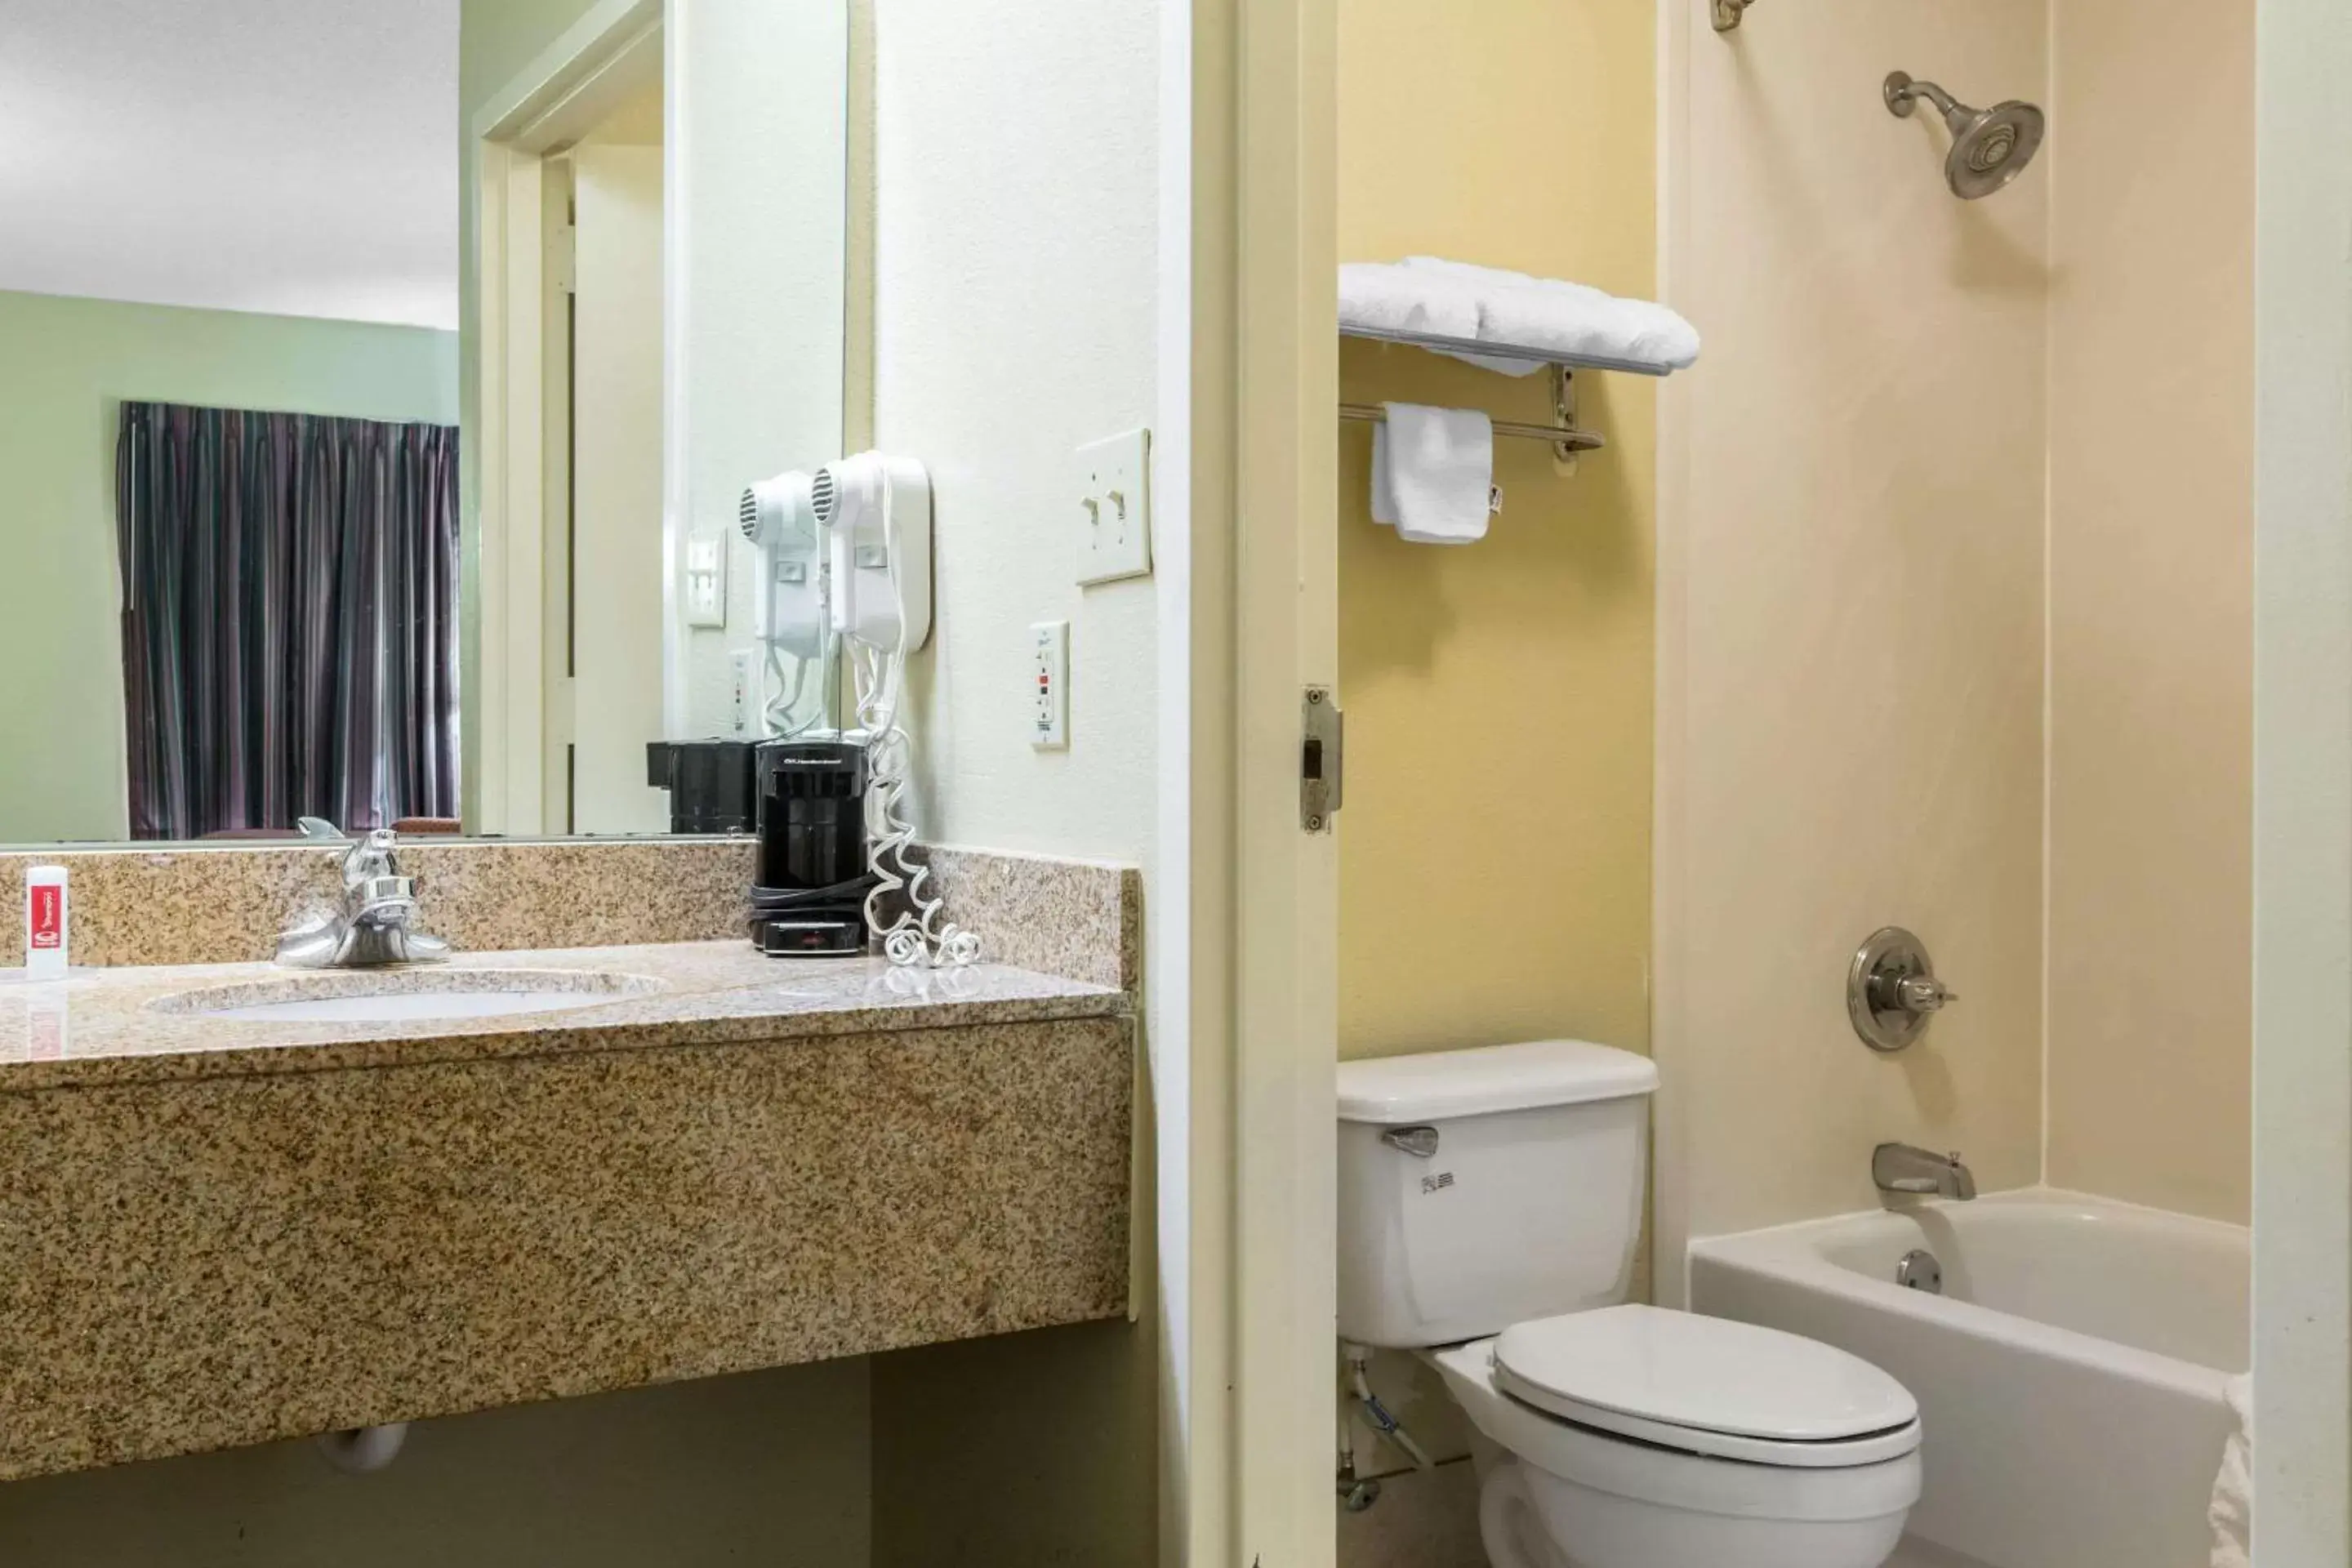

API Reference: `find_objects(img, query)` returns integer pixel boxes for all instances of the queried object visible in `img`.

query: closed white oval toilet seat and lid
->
[1494,1305,1919,1469]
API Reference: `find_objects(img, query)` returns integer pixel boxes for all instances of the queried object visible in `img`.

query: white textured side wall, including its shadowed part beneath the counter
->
[852,0,1183,1568]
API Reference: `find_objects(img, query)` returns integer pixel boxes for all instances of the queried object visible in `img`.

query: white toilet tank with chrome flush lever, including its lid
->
[1339,1039,1658,1349]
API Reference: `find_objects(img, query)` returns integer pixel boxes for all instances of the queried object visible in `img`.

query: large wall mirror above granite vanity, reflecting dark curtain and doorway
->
[0,0,849,844]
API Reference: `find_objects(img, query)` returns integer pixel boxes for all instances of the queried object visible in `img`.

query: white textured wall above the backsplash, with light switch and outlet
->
[875,0,1160,861]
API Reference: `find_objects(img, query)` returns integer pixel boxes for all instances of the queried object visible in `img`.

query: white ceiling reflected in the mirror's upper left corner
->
[0,0,459,329]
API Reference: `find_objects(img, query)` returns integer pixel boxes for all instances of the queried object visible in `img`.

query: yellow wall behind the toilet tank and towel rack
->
[1339,0,1656,1055]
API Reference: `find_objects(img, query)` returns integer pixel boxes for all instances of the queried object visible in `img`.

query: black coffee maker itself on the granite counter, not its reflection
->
[751,741,877,959]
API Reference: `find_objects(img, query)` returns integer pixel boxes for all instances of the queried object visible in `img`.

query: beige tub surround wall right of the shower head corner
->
[2048,0,2256,1223]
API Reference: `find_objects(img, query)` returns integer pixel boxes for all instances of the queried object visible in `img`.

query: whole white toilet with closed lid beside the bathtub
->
[1339,1041,1919,1568]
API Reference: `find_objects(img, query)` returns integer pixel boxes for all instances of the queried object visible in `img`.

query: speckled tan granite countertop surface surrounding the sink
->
[0,940,1134,1094]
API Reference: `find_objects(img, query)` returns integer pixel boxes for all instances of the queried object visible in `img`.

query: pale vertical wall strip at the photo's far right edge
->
[2253,0,2352,1568]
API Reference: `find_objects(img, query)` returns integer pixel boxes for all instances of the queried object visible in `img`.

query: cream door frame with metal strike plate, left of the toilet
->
[1160,0,1339,1568]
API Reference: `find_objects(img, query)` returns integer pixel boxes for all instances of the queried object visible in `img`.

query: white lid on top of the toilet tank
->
[1339,1039,1658,1126]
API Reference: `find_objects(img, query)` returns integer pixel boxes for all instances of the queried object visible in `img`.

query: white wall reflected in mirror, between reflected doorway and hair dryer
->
[666,0,849,736]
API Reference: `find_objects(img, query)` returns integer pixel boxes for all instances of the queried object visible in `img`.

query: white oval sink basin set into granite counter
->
[148,969,661,1022]
